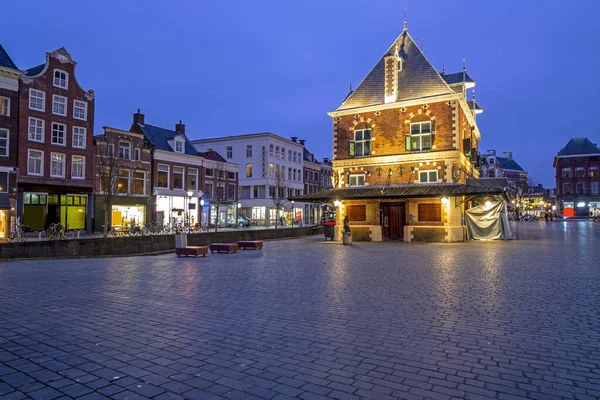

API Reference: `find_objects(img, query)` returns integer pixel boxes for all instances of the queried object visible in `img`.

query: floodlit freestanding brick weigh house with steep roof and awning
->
[301,27,502,241]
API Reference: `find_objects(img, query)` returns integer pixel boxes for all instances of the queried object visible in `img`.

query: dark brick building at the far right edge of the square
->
[553,138,600,217]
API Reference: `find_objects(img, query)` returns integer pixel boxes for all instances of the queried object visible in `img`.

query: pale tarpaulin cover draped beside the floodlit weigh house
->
[465,199,512,240]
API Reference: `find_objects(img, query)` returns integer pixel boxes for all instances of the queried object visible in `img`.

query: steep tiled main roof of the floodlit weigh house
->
[338,30,454,110]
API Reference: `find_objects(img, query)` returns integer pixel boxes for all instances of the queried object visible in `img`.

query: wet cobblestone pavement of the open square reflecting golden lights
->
[0,221,600,400]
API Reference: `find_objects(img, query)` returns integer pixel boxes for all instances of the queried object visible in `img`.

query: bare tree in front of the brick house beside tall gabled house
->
[95,142,129,237]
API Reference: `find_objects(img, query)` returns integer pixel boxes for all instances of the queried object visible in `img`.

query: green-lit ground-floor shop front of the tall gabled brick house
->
[21,192,93,231]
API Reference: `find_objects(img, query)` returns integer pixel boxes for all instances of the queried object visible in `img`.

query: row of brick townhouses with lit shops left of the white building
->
[0,45,239,238]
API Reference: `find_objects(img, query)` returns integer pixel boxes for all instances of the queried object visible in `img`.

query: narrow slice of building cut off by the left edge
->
[0,45,21,239]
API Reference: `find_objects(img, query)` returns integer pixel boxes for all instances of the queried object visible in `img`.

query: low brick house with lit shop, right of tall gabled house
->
[94,127,152,232]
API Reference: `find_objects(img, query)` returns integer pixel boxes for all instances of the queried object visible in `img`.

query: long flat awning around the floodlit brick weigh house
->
[291,183,504,202]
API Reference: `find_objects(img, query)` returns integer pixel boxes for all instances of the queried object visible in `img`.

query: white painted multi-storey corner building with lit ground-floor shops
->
[192,132,304,224]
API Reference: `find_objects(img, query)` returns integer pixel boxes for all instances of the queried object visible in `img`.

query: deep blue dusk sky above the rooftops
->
[0,0,600,187]
